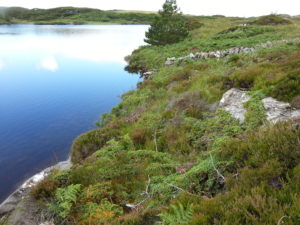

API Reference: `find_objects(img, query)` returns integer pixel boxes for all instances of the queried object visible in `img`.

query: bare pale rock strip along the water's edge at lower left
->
[0,157,72,218]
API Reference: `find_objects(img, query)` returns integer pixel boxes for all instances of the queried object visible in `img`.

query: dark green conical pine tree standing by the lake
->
[145,0,188,45]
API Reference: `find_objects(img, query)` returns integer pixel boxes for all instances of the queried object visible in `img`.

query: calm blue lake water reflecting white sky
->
[0,25,148,202]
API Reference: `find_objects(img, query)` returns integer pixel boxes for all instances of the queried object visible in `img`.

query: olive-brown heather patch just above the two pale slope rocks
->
[226,52,300,101]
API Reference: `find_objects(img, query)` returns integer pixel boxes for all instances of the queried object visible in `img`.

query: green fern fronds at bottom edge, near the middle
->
[157,203,193,225]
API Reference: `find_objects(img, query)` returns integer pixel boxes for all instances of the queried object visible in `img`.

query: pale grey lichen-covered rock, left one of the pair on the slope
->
[219,88,251,123]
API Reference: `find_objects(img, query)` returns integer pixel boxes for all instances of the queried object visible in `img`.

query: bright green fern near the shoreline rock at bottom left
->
[49,184,81,218]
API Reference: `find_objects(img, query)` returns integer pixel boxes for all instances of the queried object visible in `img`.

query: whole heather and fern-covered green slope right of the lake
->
[25,13,300,225]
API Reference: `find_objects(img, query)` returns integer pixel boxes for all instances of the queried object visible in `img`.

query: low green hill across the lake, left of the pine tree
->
[0,7,155,24]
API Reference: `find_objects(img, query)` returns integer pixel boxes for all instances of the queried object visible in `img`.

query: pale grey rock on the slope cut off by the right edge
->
[262,97,300,123]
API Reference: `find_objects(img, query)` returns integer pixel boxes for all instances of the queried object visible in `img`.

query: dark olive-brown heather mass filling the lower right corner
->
[191,123,300,225]
